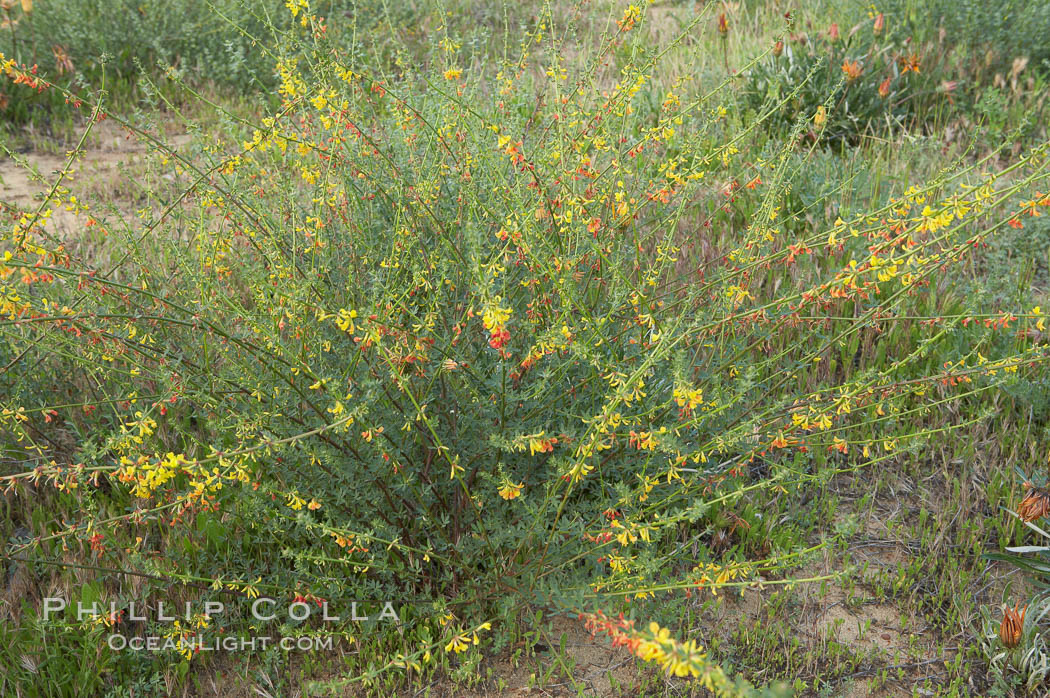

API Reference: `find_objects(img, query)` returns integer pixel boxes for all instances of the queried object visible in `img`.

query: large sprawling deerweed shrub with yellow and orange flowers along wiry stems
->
[0,0,1050,694]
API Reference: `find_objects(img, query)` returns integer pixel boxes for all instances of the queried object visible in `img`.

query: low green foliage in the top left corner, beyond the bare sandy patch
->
[0,0,291,126]
